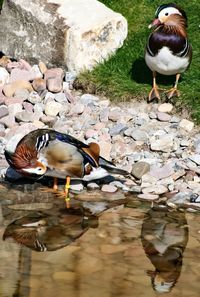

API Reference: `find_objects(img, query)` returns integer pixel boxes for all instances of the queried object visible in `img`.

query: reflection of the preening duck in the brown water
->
[3,208,98,252]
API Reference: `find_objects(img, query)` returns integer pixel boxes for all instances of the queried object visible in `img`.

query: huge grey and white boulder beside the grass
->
[0,0,127,73]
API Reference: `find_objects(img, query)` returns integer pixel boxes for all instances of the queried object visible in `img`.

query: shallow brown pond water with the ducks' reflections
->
[0,185,200,297]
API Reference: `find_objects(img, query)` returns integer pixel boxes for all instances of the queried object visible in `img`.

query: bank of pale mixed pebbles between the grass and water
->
[0,56,200,206]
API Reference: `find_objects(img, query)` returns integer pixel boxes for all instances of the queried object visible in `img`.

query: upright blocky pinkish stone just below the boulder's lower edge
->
[44,68,64,93]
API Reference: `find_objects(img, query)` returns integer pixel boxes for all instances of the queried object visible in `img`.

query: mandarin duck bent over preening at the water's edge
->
[5,129,129,207]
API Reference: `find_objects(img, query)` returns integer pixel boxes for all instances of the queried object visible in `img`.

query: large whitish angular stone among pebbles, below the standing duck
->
[150,135,174,152]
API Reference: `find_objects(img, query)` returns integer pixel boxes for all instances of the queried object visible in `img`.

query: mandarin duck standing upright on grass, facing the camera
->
[145,3,192,101]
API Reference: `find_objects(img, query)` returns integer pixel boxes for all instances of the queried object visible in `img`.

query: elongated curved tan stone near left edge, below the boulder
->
[3,80,33,97]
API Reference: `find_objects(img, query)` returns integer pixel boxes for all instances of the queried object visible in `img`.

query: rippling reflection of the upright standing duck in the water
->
[141,209,188,293]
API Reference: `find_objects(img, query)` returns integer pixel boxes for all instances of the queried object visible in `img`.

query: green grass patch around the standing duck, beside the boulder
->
[78,0,200,123]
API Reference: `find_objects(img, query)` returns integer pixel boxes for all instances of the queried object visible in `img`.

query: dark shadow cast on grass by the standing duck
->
[130,57,178,86]
